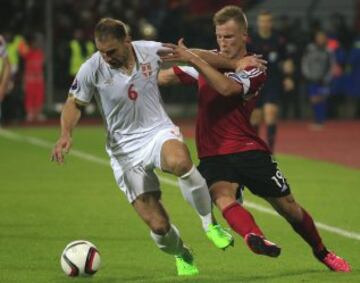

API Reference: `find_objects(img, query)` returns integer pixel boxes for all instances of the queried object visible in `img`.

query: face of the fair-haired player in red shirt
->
[215,20,247,58]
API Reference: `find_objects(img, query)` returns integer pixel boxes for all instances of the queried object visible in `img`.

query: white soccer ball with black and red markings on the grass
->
[60,240,100,276]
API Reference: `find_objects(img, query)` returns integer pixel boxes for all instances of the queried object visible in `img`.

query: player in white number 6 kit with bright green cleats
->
[52,18,233,275]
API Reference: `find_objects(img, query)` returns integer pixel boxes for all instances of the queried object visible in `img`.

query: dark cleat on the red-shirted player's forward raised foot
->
[245,233,281,257]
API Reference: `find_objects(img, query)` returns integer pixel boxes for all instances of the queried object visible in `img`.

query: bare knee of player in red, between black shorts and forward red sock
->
[210,181,239,210]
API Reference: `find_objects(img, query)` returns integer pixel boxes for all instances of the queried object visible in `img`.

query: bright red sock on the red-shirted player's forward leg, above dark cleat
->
[222,202,263,238]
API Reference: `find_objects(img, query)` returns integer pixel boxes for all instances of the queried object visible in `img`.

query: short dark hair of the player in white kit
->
[95,18,128,41]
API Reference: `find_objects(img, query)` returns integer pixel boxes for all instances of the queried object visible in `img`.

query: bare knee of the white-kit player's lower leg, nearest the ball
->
[132,191,170,234]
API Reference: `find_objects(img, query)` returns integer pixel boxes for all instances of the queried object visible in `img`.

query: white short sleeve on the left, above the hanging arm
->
[69,61,95,104]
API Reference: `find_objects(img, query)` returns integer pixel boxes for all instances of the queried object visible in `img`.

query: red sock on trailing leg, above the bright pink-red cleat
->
[290,208,325,253]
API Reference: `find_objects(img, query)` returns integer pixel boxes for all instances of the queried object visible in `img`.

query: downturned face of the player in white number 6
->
[95,37,131,68]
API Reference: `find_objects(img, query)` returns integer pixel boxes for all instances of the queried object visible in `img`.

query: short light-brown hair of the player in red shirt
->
[213,5,248,30]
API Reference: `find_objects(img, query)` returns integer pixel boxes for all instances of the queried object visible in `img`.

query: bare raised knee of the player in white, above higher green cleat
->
[161,139,193,176]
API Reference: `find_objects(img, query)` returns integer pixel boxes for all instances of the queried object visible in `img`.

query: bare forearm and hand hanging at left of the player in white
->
[51,96,81,164]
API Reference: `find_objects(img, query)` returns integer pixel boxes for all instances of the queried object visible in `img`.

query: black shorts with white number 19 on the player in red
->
[198,151,290,197]
